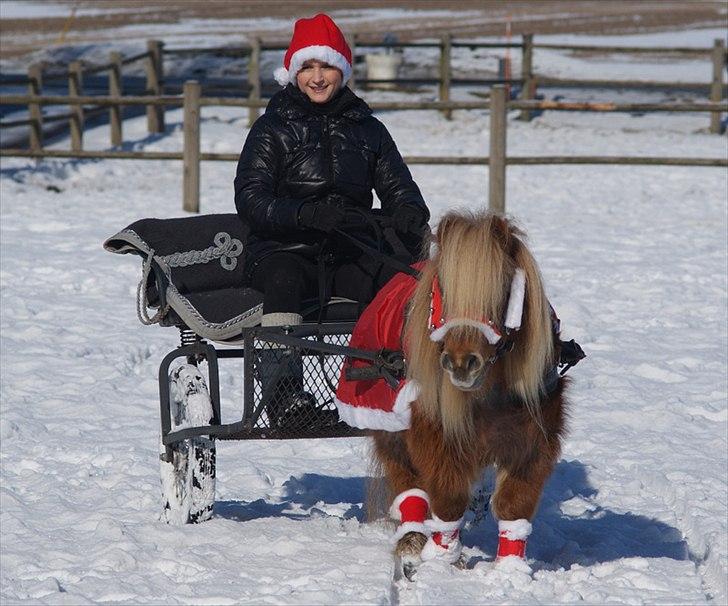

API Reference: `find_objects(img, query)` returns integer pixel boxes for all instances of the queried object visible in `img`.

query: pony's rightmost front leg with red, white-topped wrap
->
[491,461,553,559]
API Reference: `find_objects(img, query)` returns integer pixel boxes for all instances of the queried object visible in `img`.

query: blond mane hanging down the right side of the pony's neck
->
[504,238,555,430]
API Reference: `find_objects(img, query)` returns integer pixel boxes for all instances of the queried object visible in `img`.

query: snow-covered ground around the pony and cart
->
[0,22,728,604]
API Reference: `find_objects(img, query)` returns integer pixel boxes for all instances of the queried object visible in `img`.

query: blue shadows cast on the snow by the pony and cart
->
[215,461,690,569]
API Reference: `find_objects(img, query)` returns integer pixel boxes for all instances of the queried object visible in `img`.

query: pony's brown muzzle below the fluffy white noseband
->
[440,327,495,391]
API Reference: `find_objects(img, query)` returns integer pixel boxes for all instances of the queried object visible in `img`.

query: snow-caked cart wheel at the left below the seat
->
[160,364,215,525]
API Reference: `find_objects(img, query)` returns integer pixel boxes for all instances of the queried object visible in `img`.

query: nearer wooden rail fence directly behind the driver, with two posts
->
[0,81,728,212]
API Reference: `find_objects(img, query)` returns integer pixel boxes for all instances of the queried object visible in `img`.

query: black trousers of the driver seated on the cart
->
[251,252,397,314]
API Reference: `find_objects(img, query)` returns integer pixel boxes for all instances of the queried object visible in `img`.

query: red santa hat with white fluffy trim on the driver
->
[273,13,351,86]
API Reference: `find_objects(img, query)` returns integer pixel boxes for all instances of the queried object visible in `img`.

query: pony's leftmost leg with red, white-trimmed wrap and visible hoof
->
[374,432,429,563]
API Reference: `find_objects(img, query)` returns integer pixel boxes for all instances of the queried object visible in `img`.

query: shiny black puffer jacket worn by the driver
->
[235,84,429,266]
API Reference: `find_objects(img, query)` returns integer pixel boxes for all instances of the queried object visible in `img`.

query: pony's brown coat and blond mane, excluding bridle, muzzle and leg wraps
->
[373,213,566,543]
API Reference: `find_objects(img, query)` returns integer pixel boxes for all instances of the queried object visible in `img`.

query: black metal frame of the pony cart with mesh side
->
[159,322,366,455]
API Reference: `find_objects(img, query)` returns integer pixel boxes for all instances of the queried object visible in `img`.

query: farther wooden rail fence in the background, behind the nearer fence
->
[0,34,727,140]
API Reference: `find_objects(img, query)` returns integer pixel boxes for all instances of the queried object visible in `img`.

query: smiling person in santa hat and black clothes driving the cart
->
[235,14,430,422]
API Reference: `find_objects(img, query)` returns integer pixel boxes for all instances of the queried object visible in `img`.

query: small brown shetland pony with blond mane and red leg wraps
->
[373,212,566,572]
